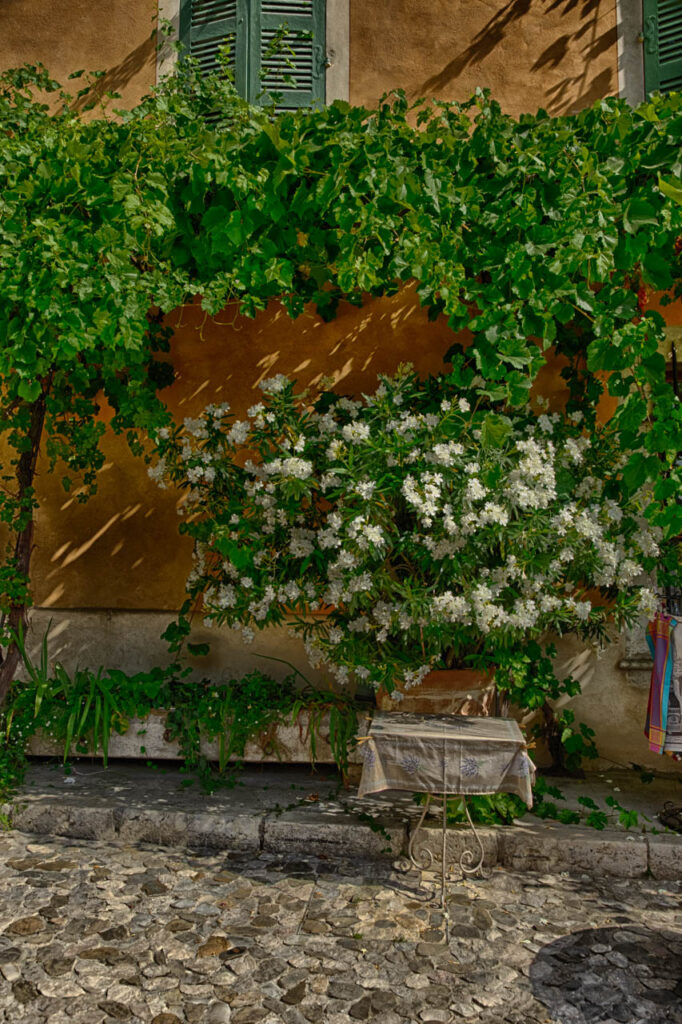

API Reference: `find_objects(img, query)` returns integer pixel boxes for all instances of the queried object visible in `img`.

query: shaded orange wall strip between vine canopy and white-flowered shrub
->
[164,287,456,419]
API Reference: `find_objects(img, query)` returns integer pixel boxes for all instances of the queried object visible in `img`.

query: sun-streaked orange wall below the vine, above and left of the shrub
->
[34,289,455,609]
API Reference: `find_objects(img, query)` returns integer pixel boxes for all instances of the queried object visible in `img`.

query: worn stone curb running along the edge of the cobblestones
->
[0,795,682,881]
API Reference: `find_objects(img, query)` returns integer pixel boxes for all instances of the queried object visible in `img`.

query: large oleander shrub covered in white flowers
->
[151,370,658,690]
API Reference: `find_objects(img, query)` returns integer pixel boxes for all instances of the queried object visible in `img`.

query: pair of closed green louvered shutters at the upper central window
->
[179,0,327,110]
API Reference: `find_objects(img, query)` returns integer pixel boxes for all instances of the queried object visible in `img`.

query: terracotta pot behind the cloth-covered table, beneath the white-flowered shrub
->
[377,669,495,716]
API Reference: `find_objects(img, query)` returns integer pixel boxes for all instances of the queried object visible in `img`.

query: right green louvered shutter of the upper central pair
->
[249,0,327,111]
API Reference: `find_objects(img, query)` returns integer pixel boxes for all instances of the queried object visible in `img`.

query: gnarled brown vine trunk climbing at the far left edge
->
[0,390,47,705]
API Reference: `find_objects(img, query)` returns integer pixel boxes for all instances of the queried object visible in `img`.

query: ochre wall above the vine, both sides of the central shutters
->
[0,0,617,114]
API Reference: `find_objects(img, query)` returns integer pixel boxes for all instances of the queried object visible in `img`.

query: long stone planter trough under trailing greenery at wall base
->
[27,711,360,764]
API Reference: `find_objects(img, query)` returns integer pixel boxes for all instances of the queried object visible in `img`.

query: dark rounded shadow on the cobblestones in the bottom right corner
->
[529,925,682,1024]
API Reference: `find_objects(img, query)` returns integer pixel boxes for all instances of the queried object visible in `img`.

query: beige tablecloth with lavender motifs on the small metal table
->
[358,712,535,807]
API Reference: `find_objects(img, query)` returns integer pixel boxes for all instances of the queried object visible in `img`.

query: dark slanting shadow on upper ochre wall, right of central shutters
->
[419,0,617,115]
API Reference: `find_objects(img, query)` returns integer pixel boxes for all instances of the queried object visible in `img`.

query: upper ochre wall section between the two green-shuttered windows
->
[350,0,617,114]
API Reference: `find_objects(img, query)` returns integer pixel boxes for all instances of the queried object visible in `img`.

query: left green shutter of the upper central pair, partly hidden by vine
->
[180,0,248,96]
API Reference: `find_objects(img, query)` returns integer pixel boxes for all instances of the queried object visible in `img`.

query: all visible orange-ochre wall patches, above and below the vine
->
[0,0,616,609]
